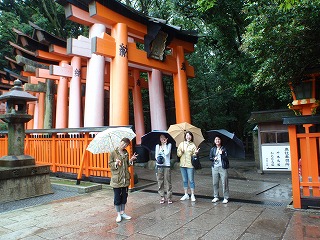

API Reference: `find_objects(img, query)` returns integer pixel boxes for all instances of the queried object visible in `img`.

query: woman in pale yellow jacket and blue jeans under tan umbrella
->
[177,131,199,202]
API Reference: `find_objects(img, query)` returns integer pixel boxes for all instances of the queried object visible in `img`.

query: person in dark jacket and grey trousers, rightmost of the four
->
[209,136,229,203]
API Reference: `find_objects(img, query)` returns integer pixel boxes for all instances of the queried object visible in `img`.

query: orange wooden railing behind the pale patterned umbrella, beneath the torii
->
[0,127,134,188]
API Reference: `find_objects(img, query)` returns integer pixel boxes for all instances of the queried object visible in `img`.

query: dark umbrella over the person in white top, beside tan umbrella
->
[141,130,176,151]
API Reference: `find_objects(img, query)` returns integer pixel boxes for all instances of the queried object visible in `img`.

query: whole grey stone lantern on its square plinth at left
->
[0,80,52,203]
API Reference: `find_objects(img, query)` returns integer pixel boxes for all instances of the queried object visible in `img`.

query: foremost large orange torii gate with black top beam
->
[58,0,197,129]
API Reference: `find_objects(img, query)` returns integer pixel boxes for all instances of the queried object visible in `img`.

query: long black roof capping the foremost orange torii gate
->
[56,0,198,44]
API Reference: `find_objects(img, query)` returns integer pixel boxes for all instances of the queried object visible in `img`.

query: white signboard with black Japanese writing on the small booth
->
[261,144,291,171]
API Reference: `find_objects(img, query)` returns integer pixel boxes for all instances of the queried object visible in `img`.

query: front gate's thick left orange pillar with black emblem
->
[110,23,129,126]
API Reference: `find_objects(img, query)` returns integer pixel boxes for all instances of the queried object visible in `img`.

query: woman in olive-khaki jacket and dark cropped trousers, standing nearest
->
[109,138,138,222]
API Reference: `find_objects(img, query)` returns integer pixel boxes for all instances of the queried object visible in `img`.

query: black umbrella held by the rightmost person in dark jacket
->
[207,129,245,158]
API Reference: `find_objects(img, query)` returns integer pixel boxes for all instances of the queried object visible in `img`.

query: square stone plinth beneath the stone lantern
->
[0,155,53,203]
